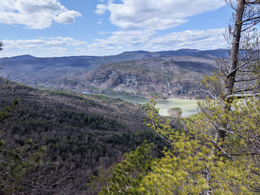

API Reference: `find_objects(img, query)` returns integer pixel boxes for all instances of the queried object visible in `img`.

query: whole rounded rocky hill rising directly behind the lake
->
[77,57,216,98]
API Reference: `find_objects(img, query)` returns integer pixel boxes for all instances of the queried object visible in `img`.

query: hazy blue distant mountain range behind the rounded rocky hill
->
[0,49,226,97]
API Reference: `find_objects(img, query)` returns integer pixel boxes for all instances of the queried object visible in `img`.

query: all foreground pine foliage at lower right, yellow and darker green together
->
[89,92,260,195]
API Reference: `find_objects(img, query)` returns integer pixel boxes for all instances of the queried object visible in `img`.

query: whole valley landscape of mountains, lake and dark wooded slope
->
[0,50,223,194]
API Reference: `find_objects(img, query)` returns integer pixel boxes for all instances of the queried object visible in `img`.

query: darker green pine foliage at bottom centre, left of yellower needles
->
[88,141,156,194]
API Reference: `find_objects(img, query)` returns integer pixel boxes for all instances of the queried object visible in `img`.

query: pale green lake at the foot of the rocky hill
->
[82,92,197,116]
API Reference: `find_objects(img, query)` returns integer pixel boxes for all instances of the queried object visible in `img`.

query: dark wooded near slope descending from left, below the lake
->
[0,83,173,191]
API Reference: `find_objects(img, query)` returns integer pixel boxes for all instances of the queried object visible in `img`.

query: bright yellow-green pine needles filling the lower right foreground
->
[140,99,260,194]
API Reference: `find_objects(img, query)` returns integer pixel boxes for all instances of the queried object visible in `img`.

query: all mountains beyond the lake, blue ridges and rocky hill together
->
[0,49,227,98]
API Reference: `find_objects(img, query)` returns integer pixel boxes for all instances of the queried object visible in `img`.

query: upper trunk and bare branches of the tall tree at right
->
[222,0,260,99]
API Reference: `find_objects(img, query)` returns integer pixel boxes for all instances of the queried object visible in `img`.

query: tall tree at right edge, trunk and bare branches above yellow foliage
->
[205,0,260,141]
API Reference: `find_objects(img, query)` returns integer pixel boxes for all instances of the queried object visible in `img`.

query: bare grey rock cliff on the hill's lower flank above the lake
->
[89,70,205,98]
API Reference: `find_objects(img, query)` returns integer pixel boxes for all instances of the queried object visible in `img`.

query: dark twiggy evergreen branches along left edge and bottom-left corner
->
[0,42,77,194]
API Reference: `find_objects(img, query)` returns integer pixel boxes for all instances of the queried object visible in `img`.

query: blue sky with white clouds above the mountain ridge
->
[0,0,233,57]
